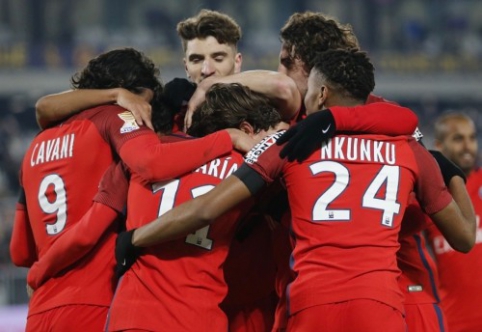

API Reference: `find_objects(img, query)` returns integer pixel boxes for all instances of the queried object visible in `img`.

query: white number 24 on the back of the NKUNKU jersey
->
[310,161,400,227]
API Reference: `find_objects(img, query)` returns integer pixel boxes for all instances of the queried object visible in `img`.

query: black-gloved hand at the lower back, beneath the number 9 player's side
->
[115,229,141,278]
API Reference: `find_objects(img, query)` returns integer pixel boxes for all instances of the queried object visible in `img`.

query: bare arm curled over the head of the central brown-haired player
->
[185,70,301,128]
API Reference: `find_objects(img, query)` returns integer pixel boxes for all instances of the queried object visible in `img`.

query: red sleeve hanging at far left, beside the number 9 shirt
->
[10,188,37,267]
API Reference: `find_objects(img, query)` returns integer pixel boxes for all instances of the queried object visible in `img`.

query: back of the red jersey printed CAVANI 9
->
[21,108,119,314]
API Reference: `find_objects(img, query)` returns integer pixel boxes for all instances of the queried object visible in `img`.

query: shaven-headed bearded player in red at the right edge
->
[429,113,482,332]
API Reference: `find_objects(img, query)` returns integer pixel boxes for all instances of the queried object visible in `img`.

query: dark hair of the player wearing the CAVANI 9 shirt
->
[71,48,163,95]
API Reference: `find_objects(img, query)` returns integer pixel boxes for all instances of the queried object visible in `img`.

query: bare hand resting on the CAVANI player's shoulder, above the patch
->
[116,88,154,130]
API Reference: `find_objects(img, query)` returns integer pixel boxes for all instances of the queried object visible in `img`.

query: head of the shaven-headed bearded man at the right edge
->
[435,117,477,174]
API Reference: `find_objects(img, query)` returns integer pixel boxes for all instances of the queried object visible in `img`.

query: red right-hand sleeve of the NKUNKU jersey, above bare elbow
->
[410,140,453,215]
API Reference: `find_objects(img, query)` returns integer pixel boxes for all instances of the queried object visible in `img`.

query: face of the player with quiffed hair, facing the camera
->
[184,36,242,84]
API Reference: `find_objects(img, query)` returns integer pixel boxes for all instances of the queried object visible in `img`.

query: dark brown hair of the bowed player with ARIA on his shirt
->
[188,83,281,137]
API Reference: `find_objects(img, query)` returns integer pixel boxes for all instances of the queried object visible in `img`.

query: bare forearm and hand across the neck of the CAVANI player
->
[35,88,153,129]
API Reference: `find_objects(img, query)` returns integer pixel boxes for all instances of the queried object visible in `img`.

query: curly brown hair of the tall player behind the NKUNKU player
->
[280,12,359,72]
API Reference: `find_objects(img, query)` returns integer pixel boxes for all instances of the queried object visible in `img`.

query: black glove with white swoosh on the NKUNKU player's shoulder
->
[276,109,336,162]
